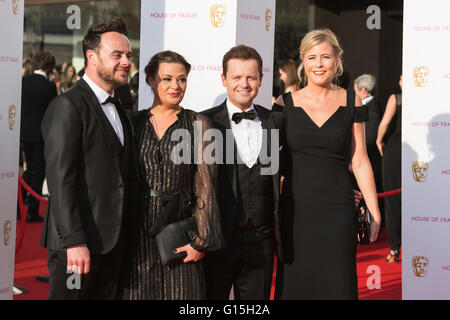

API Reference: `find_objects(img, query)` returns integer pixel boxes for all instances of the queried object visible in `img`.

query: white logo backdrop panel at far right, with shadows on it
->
[402,0,450,299]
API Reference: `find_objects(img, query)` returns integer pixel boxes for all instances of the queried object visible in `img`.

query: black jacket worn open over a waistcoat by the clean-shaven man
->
[201,101,284,261]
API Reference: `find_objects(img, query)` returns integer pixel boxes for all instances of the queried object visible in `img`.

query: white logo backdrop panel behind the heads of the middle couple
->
[139,0,275,111]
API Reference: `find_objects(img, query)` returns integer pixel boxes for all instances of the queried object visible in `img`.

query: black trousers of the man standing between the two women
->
[205,225,274,300]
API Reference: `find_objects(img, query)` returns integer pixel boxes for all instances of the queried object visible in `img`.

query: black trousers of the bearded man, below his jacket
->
[48,228,127,300]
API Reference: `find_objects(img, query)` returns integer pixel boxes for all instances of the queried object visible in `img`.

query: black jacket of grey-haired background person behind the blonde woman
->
[366,98,381,174]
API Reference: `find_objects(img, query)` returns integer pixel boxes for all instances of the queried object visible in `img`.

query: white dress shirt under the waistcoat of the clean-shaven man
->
[227,99,263,168]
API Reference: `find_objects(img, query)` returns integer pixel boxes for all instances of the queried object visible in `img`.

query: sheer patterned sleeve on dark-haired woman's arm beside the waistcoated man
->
[191,115,224,251]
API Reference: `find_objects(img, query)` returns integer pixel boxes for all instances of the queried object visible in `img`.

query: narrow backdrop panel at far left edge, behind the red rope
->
[0,0,24,300]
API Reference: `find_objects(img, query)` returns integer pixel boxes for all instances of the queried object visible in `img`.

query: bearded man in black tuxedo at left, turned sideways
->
[41,18,137,299]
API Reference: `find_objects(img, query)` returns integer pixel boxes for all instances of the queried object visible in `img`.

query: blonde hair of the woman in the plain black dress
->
[297,29,344,86]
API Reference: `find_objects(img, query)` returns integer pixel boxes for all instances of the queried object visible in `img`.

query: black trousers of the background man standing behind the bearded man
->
[22,141,45,216]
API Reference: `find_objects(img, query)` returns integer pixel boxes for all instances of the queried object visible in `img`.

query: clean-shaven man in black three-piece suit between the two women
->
[202,45,283,300]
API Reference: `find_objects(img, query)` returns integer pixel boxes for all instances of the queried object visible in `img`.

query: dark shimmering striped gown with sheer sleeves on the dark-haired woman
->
[122,109,223,300]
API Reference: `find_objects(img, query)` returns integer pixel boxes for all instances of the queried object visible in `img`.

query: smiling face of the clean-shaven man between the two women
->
[222,59,262,110]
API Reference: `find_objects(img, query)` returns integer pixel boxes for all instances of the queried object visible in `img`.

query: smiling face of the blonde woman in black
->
[302,41,340,86]
